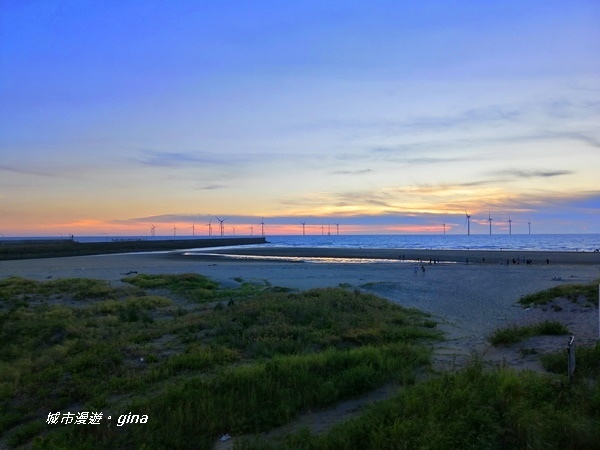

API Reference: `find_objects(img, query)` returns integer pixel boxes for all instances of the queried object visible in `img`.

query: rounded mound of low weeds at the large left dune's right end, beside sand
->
[206,288,440,358]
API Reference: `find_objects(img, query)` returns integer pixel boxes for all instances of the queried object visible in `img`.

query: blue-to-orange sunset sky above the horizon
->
[0,0,600,237]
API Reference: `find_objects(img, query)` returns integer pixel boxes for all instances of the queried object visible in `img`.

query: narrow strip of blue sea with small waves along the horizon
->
[0,234,600,252]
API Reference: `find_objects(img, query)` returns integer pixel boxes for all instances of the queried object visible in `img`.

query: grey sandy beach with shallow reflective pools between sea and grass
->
[0,247,600,369]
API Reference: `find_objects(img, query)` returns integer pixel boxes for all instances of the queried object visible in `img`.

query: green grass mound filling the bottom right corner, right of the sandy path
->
[237,362,600,450]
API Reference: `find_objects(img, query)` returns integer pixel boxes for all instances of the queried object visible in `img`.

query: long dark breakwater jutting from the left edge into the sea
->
[0,237,266,261]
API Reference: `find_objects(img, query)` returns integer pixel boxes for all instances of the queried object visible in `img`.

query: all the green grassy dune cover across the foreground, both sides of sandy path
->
[0,274,600,449]
